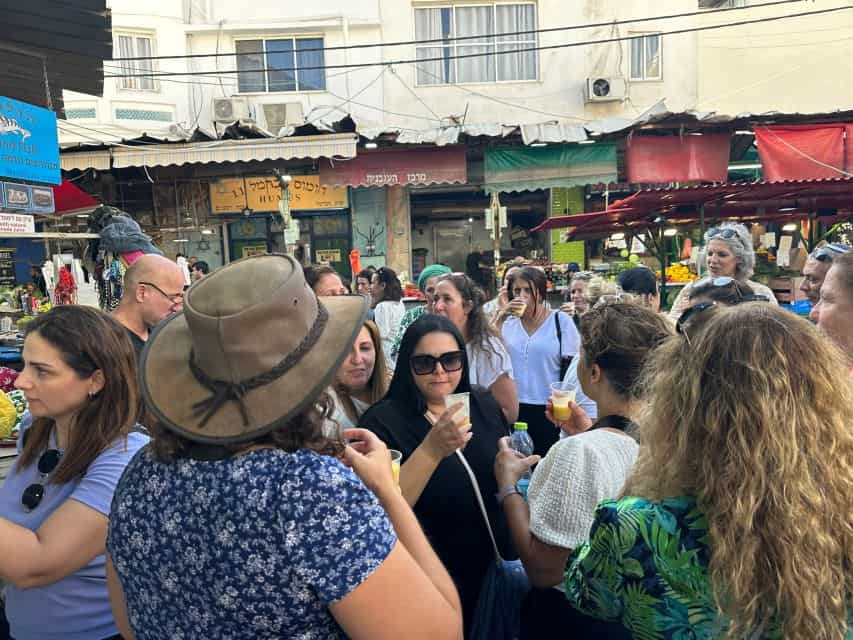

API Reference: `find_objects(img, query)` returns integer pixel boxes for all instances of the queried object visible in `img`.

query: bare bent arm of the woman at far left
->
[0,498,108,589]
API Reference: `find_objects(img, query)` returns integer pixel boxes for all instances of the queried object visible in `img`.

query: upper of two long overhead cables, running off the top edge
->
[106,0,805,61]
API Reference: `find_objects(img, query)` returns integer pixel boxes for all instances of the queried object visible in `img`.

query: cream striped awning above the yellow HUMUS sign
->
[111,133,358,169]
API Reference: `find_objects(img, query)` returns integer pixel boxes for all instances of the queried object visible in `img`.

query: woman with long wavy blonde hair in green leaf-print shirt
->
[565,303,853,640]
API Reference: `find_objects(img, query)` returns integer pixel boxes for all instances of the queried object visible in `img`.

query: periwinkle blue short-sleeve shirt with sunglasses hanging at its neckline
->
[0,414,148,640]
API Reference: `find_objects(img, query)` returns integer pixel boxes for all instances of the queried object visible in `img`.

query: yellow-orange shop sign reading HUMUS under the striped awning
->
[210,176,349,213]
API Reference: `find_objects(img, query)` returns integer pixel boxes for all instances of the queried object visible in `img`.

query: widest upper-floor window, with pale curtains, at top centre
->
[415,4,536,85]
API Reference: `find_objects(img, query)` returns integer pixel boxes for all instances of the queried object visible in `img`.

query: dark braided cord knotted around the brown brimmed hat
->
[189,300,329,429]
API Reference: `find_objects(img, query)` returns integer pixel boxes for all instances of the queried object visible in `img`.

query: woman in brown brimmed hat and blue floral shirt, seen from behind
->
[107,255,462,640]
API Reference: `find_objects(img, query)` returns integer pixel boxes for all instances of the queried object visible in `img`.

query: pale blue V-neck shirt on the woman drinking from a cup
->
[503,311,580,405]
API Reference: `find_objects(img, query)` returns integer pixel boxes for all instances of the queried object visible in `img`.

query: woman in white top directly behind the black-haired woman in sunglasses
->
[433,274,518,424]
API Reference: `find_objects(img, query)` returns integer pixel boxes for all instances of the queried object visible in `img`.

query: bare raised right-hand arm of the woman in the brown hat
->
[329,429,462,640]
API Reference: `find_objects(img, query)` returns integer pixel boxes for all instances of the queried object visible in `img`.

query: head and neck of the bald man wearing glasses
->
[113,254,184,360]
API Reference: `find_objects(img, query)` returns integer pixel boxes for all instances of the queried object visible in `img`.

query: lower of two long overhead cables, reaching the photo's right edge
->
[104,0,853,78]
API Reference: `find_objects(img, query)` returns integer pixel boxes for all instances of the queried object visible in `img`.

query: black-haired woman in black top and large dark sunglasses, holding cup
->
[360,315,516,635]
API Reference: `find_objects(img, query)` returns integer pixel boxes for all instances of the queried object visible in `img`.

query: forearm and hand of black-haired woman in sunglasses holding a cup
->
[400,402,473,507]
